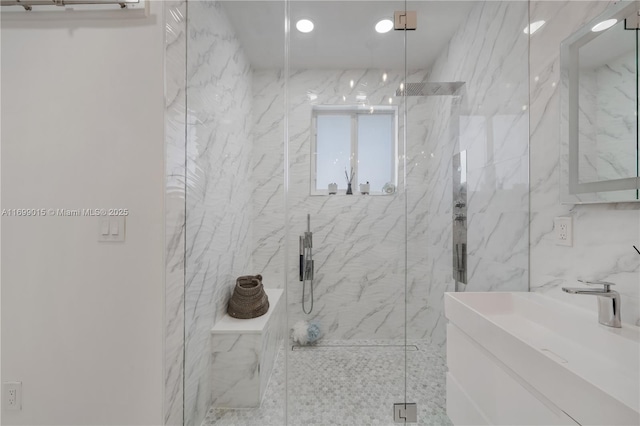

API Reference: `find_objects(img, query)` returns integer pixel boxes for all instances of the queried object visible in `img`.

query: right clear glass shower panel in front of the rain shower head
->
[405,1,529,425]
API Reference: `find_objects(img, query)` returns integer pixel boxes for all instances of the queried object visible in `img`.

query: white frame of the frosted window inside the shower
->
[309,105,398,195]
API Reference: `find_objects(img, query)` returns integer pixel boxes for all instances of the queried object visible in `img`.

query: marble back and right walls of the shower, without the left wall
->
[253,2,528,345]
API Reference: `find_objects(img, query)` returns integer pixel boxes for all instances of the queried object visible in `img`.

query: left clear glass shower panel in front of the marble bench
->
[182,0,286,426]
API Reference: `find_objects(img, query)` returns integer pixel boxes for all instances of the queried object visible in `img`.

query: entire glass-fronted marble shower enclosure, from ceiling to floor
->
[165,0,529,425]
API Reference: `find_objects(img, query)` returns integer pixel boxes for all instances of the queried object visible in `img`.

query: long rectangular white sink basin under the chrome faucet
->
[445,292,640,425]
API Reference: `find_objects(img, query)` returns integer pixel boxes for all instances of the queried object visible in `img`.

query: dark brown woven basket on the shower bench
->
[227,275,269,319]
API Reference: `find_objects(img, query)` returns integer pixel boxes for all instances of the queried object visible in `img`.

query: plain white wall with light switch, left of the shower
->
[1,4,164,425]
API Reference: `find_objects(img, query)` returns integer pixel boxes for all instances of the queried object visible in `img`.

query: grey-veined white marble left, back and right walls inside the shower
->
[168,2,528,424]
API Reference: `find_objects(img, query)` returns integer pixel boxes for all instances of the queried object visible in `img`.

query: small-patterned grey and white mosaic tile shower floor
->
[202,341,451,426]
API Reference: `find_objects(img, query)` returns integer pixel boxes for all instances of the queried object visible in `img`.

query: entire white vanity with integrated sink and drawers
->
[445,292,640,426]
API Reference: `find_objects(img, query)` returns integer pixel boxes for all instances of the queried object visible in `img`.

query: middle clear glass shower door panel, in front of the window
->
[286,1,406,425]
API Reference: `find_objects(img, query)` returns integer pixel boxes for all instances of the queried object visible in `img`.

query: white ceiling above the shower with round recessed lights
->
[221,0,474,69]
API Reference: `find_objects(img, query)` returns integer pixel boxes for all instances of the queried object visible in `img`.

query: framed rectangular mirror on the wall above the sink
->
[560,1,640,204]
